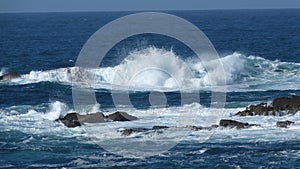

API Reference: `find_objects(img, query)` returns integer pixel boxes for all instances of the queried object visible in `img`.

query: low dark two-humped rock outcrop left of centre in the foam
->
[56,112,138,127]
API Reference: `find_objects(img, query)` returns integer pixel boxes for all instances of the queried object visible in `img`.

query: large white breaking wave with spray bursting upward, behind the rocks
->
[1,47,300,91]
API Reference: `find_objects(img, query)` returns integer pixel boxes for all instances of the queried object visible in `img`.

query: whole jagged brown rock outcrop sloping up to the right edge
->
[235,96,300,116]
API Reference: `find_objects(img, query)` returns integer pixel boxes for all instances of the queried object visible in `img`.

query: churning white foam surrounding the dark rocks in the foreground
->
[0,101,300,142]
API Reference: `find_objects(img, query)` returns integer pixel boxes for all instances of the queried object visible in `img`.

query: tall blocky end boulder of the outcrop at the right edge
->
[272,96,300,114]
